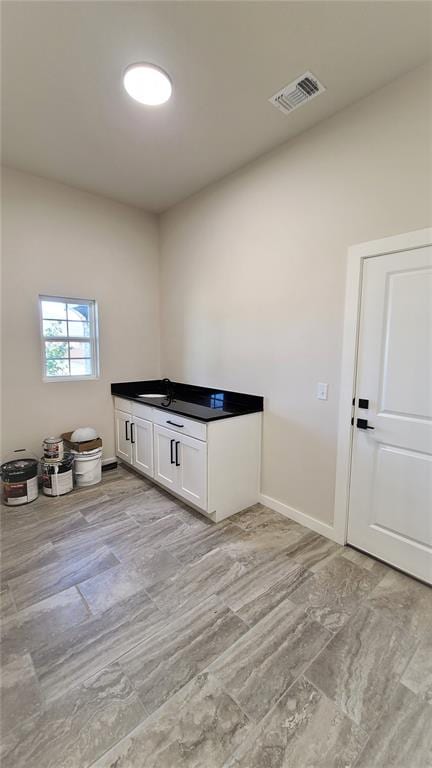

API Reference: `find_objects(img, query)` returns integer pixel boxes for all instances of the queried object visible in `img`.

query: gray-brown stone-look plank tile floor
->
[0,468,432,768]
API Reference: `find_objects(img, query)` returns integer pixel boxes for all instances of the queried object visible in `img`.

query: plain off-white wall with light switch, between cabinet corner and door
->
[161,67,432,522]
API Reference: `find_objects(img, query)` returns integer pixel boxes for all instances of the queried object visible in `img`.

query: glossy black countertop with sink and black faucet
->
[111,379,264,422]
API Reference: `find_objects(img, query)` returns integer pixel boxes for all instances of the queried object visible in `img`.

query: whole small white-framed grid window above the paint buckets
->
[39,296,99,381]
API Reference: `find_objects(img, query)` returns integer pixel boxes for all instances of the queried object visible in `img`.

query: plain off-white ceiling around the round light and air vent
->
[2,0,432,211]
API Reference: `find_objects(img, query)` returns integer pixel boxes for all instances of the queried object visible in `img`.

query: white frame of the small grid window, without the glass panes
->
[39,294,99,383]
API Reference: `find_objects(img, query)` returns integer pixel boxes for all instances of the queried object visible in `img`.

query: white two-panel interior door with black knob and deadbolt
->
[348,247,432,583]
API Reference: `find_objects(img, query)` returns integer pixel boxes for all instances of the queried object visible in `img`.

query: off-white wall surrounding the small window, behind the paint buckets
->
[2,169,160,457]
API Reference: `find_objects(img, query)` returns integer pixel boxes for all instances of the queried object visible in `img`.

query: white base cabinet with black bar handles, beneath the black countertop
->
[114,397,262,522]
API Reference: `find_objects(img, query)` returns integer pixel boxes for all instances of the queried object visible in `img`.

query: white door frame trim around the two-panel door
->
[333,227,432,544]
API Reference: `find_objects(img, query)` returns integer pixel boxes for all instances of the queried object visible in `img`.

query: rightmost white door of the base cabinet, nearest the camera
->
[175,435,207,510]
